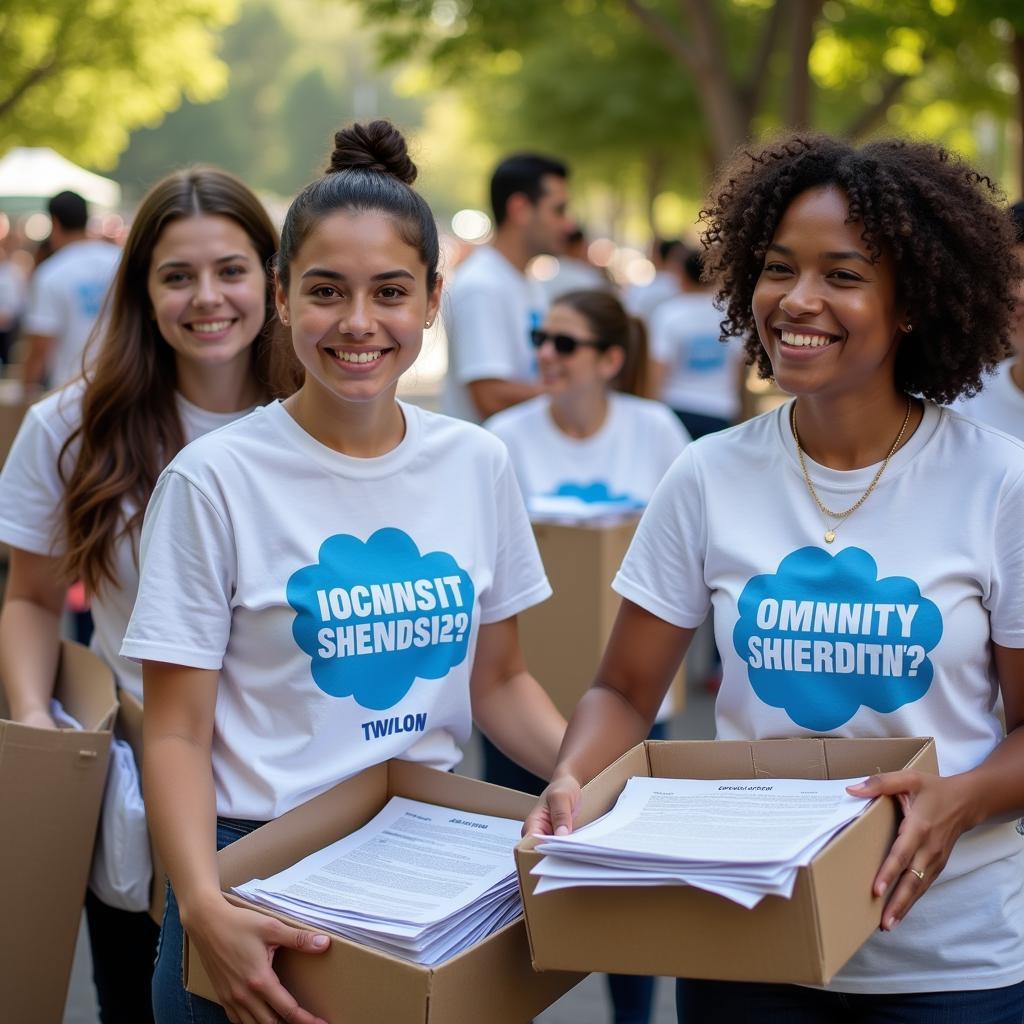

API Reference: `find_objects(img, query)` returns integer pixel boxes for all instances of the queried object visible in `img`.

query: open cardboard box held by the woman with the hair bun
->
[184,761,583,1024]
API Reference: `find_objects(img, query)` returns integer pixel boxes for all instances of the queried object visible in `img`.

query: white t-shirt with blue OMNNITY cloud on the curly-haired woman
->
[613,404,1024,992]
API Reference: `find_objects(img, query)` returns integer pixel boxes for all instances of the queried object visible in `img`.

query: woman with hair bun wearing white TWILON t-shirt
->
[122,121,564,1024]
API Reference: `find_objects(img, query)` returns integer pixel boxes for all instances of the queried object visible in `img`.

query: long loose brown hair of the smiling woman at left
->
[59,167,302,593]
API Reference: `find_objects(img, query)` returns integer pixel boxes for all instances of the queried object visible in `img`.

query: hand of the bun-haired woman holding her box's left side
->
[186,899,331,1024]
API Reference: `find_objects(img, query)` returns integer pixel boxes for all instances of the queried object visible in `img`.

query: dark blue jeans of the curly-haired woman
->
[676,978,1024,1024]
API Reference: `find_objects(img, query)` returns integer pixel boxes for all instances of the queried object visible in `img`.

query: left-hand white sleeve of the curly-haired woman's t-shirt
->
[611,449,711,629]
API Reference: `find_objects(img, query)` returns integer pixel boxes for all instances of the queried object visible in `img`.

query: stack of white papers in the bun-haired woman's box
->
[233,797,522,964]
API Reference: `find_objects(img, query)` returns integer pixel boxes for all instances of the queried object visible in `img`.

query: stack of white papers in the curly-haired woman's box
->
[532,777,869,907]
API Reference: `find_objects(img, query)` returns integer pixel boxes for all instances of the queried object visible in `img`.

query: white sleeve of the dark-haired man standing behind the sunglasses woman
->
[446,286,525,384]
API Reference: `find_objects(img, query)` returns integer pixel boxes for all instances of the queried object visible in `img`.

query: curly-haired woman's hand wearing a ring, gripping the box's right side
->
[849,769,976,932]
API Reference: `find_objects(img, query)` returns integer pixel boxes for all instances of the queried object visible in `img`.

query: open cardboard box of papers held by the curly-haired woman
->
[516,738,938,985]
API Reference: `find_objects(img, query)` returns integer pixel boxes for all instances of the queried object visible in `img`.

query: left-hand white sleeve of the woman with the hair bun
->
[121,467,238,669]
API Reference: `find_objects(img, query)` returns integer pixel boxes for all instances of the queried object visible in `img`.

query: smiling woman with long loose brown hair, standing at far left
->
[0,168,300,1024]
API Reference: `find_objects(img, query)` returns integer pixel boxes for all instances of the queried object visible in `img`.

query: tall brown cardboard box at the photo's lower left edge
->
[0,641,117,1024]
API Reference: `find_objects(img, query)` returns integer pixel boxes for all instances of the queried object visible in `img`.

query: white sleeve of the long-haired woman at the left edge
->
[0,397,66,557]
